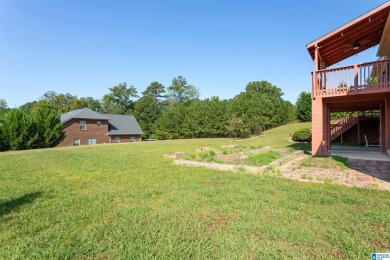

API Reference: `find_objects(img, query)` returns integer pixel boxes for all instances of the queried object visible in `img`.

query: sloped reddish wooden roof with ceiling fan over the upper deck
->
[306,1,390,68]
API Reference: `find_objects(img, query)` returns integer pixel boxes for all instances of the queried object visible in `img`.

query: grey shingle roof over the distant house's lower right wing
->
[102,114,143,135]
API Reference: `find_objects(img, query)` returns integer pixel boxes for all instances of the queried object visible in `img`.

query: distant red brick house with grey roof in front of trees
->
[58,108,143,147]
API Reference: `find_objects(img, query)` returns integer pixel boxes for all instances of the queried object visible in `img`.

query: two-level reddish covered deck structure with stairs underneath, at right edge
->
[306,2,390,155]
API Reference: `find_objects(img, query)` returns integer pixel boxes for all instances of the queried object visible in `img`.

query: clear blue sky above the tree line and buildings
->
[0,0,386,107]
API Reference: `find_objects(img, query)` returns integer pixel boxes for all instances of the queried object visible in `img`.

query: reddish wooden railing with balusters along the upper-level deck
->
[312,59,390,97]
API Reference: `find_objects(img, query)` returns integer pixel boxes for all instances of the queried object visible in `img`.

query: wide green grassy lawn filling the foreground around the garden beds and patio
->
[0,124,390,259]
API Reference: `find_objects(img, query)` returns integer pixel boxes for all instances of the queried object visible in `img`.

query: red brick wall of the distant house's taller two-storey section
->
[58,119,110,146]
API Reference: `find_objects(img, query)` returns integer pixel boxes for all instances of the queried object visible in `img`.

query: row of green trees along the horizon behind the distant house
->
[0,76,308,150]
